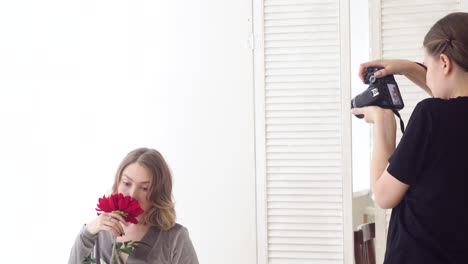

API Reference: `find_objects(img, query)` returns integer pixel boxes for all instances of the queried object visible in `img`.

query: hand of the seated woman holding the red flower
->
[86,213,129,237]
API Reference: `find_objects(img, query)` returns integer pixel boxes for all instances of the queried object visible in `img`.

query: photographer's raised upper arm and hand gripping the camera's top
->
[359,60,432,96]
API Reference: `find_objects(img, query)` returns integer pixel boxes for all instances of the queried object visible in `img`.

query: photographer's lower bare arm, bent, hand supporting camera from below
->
[352,106,409,209]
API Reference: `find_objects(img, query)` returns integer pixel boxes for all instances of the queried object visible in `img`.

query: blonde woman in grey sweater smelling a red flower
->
[68,148,198,264]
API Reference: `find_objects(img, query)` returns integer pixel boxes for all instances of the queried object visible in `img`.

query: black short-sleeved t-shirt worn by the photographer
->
[384,97,468,264]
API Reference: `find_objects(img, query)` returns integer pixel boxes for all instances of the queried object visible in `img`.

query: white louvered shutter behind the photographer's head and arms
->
[369,0,463,263]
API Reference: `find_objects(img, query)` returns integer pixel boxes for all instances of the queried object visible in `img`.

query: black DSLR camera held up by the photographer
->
[351,67,404,118]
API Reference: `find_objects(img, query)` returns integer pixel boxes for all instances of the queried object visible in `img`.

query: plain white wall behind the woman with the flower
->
[0,0,256,264]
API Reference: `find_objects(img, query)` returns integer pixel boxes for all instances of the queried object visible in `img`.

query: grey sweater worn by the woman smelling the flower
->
[68,224,198,264]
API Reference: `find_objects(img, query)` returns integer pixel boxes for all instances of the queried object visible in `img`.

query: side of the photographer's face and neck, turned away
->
[424,50,448,98]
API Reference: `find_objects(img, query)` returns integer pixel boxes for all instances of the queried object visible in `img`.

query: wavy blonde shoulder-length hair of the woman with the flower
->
[112,148,176,230]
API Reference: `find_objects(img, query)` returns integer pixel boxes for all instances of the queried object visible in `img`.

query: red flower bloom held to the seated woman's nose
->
[96,193,144,224]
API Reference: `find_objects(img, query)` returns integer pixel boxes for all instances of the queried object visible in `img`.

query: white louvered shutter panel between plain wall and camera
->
[255,0,353,264]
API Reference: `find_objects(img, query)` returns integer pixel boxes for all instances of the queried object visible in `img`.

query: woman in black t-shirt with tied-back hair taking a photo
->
[352,13,468,264]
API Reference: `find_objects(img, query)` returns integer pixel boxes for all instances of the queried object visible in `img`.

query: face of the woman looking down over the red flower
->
[117,163,152,211]
